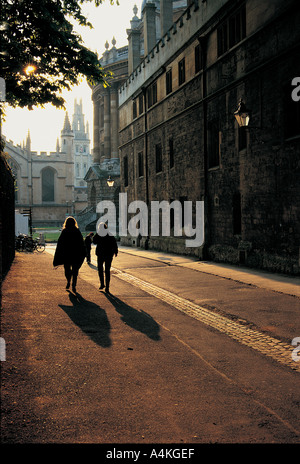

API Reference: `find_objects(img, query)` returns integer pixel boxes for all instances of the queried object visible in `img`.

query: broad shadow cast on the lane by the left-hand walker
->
[59,292,111,348]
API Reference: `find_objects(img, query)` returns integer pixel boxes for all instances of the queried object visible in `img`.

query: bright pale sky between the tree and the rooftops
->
[2,0,142,152]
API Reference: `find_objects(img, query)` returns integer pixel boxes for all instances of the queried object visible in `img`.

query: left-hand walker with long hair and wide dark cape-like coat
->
[53,216,86,292]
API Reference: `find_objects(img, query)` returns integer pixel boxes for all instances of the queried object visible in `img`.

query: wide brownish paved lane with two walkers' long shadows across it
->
[1,248,300,444]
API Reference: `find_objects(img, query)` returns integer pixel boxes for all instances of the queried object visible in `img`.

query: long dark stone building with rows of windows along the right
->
[119,0,300,274]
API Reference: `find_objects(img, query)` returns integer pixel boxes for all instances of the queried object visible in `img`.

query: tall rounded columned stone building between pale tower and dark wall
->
[77,38,128,230]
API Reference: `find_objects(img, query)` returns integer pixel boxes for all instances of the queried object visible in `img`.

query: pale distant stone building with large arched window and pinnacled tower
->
[4,100,91,226]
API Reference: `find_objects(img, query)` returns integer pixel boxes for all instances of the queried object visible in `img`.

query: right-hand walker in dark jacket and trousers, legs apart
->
[93,222,118,293]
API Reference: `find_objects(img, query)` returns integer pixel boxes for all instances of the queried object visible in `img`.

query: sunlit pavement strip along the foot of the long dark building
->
[119,246,300,297]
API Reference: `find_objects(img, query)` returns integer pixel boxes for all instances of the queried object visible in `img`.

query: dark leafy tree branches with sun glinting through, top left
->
[0,0,118,109]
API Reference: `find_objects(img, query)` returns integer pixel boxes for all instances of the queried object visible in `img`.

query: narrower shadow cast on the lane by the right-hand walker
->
[104,293,160,341]
